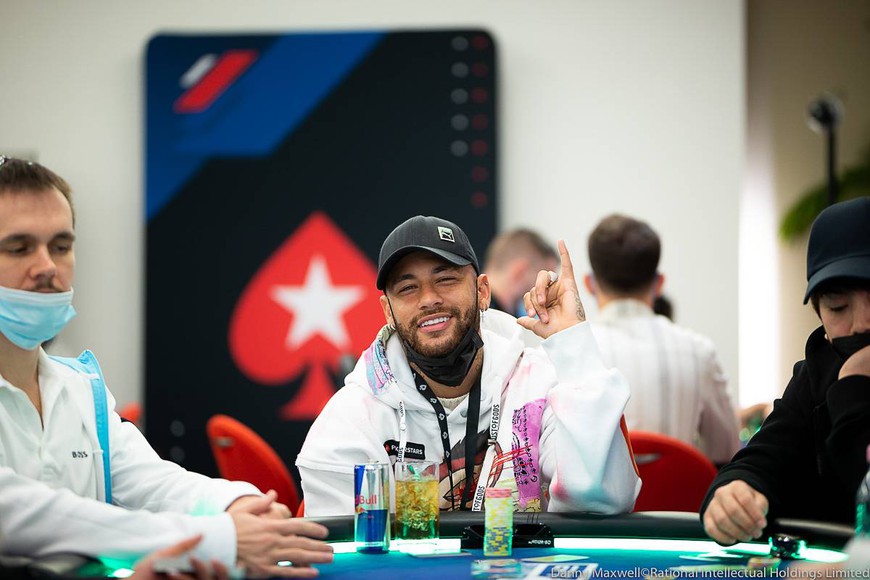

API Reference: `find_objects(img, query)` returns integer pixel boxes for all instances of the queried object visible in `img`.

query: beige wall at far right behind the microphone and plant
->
[740,0,870,402]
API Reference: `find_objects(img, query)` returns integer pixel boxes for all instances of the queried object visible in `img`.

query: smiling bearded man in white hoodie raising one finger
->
[296,216,640,516]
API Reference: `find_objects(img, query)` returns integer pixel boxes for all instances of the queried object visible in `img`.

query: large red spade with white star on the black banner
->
[229,212,384,420]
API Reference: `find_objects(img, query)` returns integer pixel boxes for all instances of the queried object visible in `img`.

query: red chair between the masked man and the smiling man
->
[205,415,299,514]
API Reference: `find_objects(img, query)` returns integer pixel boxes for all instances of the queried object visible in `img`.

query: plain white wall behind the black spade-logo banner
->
[0,0,744,410]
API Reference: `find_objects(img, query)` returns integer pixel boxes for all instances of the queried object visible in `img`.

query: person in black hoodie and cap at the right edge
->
[701,197,870,544]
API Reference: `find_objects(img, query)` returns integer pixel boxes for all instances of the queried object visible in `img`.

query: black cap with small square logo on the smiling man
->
[377,215,480,290]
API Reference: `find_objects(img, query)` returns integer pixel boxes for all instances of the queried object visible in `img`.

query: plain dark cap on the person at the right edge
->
[804,197,870,304]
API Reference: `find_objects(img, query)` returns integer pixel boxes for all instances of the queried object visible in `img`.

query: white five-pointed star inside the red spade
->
[271,256,365,349]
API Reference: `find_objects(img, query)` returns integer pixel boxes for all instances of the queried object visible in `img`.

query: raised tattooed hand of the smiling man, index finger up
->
[517,240,586,338]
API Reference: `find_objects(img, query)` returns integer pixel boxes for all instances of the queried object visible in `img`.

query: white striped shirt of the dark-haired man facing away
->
[591,299,740,463]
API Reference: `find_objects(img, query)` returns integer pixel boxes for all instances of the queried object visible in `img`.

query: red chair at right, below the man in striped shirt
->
[629,431,716,512]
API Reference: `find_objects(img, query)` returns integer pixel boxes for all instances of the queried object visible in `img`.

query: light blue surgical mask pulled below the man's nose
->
[0,286,76,350]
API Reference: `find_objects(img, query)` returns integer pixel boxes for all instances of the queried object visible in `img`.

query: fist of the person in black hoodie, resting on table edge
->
[704,479,768,546]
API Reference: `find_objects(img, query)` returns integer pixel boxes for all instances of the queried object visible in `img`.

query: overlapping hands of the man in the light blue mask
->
[228,505,333,578]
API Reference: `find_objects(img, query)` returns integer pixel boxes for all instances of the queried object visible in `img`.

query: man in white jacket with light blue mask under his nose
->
[0,155,332,576]
